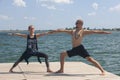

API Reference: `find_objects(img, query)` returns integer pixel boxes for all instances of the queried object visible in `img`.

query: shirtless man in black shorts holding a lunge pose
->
[56,20,110,75]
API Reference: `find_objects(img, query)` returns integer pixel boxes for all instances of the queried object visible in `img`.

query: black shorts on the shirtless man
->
[67,45,90,58]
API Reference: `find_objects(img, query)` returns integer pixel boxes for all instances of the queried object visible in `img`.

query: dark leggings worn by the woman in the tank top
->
[12,51,49,68]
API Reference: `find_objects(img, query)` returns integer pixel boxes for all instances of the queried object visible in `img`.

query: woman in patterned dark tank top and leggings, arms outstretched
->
[9,25,53,72]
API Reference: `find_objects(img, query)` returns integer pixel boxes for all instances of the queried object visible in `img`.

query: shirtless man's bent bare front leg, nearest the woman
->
[56,52,67,73]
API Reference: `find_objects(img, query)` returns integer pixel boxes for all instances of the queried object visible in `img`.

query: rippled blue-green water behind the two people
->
[0,31,120,76]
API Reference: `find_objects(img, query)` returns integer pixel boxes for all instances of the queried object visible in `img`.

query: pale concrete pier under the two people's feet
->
[0,62,120,80]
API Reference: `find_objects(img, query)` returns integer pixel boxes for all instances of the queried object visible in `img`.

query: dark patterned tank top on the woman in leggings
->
[27,35,38,52]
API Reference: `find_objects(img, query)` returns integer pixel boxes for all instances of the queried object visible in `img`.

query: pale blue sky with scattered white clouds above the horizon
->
[0,0,120,30]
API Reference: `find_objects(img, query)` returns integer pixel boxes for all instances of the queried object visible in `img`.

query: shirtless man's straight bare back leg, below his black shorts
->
[86,57,105,75]
